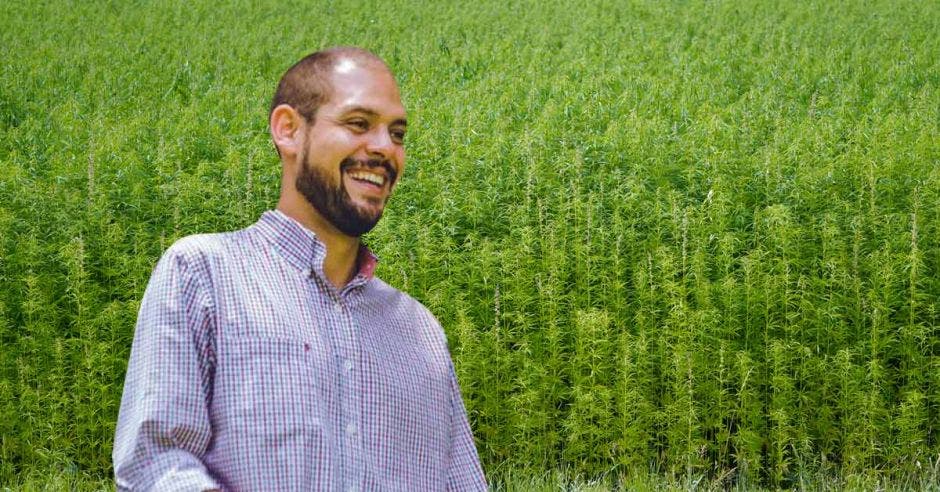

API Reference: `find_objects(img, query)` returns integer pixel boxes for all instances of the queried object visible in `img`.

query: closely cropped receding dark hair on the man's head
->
[268,46,388,122]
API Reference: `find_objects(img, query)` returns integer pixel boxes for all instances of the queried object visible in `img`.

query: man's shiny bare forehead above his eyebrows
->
[324,59,405,120]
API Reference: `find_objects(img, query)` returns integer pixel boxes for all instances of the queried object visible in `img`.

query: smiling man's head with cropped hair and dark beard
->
[269,47,407,237]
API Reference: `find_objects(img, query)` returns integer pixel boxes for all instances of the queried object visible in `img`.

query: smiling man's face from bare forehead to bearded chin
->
[295,60,407,237]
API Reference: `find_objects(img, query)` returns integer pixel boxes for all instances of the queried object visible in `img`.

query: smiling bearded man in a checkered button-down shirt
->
[113,48,486,491]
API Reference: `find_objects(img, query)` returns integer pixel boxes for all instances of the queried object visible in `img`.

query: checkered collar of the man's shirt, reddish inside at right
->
[257,210,379,283]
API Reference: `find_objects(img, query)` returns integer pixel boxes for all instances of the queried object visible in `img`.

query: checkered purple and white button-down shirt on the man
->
[113,211,486,491]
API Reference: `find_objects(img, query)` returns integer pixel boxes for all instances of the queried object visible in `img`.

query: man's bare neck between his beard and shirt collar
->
[277,197,359,289]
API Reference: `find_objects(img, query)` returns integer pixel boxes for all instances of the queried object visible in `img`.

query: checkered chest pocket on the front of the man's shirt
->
[229,337,325,434]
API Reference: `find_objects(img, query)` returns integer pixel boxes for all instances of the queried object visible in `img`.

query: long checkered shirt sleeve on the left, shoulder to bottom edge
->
[112,247,219,491]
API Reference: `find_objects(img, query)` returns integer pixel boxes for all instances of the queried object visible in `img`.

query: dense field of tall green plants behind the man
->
[0,0,940,487]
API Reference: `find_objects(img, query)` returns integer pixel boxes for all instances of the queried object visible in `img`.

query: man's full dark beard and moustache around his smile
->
[294,150,397,237]
